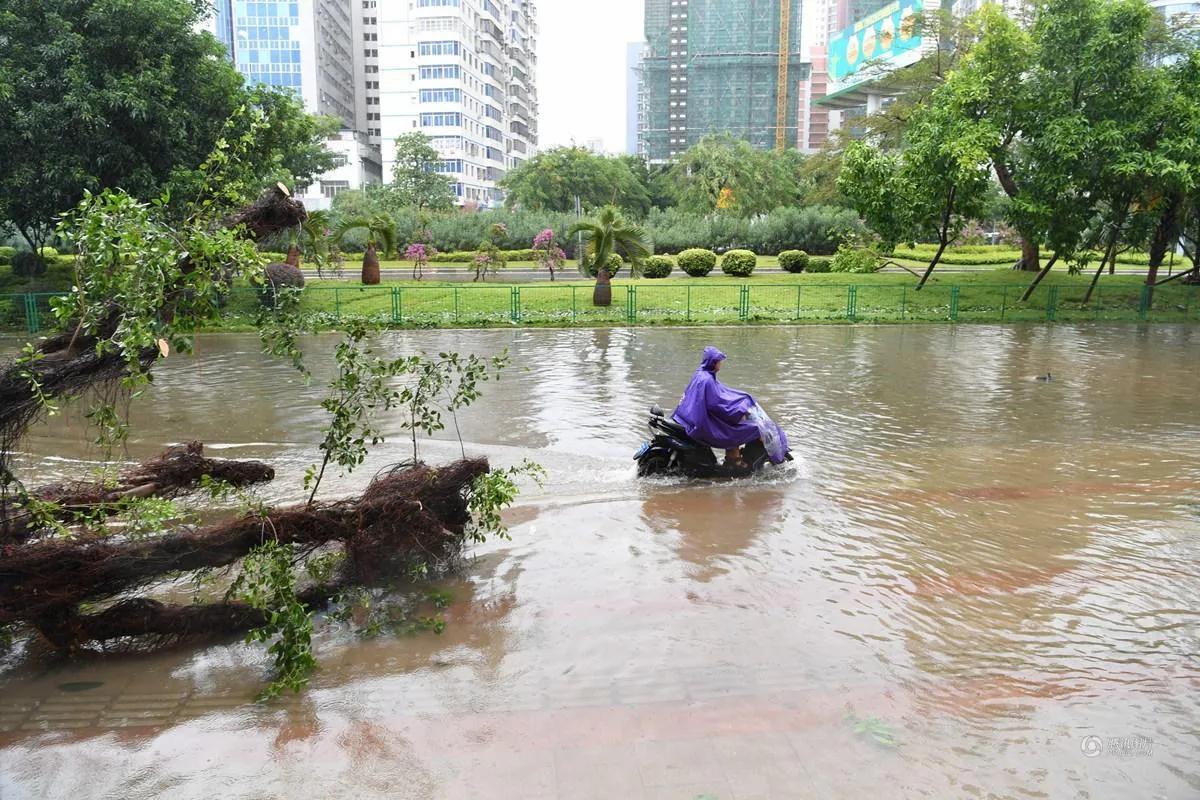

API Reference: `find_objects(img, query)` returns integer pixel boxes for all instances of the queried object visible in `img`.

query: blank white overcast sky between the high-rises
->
[538,0,642,152]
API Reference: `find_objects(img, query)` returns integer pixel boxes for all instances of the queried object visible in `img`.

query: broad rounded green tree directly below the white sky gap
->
[500,148,652,214]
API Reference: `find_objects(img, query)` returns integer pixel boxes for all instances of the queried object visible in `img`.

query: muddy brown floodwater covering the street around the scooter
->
[0,325,1200,800]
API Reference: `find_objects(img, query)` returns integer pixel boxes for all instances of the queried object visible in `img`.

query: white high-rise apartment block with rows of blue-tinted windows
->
[376,0,538,206]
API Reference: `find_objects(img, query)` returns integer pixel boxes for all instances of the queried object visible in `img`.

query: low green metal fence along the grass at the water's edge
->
[0,283,1200,333]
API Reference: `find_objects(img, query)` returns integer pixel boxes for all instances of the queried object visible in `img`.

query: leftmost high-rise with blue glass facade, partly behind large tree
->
[206,0,382,207]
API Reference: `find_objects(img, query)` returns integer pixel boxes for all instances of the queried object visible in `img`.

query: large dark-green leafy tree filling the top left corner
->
[0,0,338,253]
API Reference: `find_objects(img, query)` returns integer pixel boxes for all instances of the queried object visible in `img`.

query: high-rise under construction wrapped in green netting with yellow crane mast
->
[640,0,809,163]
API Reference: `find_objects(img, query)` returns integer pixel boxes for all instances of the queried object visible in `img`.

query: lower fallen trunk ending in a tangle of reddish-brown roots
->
[0,459,488,651]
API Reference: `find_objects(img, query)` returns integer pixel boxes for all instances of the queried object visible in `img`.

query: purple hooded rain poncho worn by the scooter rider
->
[673,345,787,464]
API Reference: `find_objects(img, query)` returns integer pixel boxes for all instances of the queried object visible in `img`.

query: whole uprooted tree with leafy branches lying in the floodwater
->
[0,112,535,696]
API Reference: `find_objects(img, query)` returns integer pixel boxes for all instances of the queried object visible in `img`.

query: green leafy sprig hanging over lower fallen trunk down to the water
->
[228,539,317,700]
